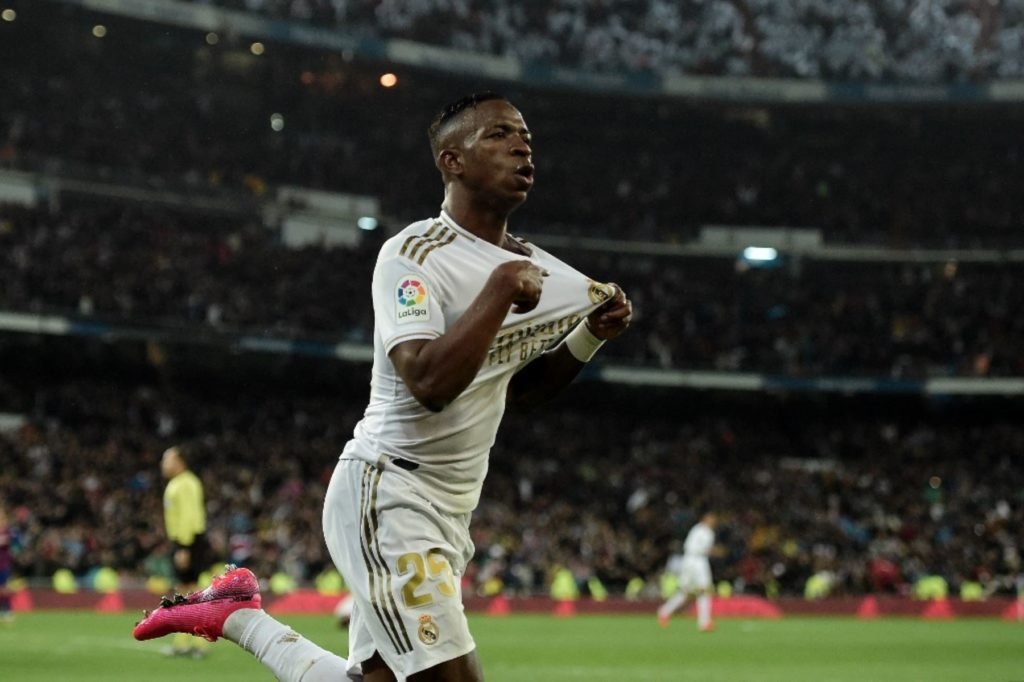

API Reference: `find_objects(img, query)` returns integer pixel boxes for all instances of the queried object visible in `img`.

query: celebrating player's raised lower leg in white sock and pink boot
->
[133,566,361,682]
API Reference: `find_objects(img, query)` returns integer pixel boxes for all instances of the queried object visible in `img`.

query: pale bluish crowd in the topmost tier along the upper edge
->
[194,0,1024,82]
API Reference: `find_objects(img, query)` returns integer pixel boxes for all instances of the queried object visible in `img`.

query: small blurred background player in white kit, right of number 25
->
[657,512,718,632]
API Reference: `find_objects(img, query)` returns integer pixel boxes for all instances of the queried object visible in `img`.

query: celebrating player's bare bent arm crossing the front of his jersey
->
[388,260,544,412]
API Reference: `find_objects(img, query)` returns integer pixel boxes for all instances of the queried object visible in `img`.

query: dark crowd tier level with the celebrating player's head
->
[0,10,1024,248]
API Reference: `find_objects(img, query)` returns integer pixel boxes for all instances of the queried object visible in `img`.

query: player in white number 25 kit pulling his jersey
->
[135,93,632,682]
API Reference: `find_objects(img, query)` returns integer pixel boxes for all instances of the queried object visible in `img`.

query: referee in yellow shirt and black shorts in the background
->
[160,445,210,657]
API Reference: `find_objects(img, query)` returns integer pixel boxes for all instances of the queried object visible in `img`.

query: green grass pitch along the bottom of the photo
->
[0,611,1024,682]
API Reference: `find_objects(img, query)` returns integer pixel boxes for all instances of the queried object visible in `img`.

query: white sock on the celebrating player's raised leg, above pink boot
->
[224,608,361,682]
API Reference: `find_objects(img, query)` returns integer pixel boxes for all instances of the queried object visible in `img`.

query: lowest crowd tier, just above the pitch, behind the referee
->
[0,382,1024,595]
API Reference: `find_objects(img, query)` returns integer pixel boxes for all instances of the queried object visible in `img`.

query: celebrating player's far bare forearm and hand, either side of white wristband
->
[507,285,633,410]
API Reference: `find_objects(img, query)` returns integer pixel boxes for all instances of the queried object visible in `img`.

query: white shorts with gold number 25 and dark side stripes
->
[324,459,476,682]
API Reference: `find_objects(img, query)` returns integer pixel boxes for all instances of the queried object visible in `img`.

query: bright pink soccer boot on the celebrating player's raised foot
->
[132,565,262,642]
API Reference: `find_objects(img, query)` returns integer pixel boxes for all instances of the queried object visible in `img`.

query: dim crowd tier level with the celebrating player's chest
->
[0,202,1024,379]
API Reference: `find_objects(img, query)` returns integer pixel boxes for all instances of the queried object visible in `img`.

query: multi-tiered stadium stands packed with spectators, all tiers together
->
[0,0,1024,596]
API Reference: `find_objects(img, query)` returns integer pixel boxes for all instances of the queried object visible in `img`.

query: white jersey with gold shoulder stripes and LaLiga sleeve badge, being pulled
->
[342,212,614,513]
